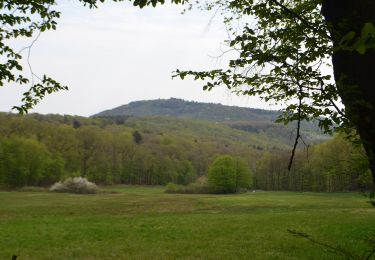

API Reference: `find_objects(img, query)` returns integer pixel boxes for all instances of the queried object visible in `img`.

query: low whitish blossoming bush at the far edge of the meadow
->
[50,177,99,194]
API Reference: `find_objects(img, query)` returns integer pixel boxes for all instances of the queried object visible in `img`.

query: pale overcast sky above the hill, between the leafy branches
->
[0,1,275,116]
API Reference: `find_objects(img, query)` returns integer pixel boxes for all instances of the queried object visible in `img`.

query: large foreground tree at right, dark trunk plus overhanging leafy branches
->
[175,0,375,184]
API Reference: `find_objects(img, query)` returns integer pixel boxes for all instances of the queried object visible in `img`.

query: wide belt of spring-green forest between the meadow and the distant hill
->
[0,99,371,191]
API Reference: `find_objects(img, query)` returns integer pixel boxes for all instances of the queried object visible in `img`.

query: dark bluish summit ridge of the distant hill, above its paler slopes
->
[94,98,279,122]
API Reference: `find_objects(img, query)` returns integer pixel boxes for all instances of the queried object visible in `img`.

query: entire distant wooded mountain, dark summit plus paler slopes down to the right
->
[92,98,329,145]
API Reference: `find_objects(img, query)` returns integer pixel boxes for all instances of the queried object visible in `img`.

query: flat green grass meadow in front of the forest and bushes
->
[0,187,375,259]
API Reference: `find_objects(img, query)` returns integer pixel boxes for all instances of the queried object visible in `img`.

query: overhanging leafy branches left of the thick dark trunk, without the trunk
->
[176,0,348,132]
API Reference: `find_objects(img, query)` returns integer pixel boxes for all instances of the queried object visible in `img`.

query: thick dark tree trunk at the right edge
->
[322,0,375,185]
